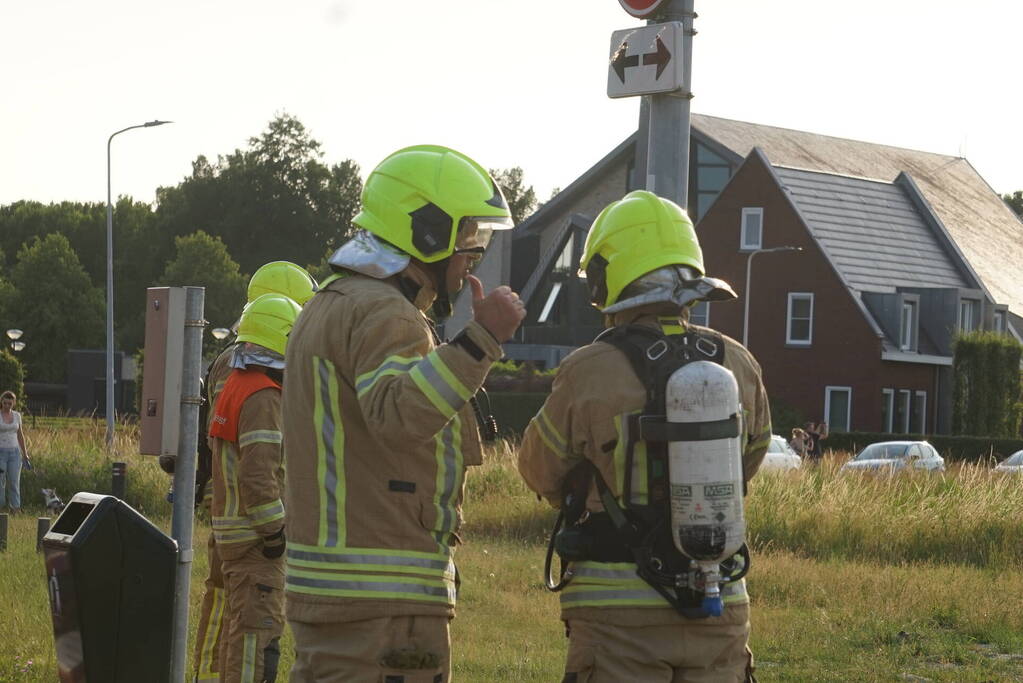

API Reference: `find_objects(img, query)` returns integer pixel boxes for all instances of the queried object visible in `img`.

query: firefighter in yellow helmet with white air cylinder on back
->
[519,190,771,683]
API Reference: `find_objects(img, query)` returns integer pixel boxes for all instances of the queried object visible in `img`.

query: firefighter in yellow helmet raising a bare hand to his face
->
[283,145,525,683]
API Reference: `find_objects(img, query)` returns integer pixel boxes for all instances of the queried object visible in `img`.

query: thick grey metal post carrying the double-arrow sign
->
[640,0,696,209]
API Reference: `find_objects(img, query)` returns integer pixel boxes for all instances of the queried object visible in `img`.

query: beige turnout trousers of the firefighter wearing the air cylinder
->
[563,604,755,683]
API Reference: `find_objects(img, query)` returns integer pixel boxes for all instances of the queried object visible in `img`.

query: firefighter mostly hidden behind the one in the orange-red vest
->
[194,261,317,682]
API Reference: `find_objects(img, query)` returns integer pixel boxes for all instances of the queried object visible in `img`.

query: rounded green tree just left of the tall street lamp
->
[7,233,105,382]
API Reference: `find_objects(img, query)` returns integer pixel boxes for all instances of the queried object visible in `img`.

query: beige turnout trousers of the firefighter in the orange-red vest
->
[219,545,284,683]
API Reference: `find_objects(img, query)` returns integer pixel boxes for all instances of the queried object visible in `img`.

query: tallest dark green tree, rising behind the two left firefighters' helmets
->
[157,113,362,273]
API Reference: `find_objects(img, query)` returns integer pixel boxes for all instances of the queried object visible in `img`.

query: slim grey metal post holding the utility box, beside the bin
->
[171,287,206,683]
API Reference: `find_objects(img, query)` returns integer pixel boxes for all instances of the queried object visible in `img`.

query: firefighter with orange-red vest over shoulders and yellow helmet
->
[210,293,302,683]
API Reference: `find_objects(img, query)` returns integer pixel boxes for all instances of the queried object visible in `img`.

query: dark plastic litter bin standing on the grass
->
[43,493,178,683]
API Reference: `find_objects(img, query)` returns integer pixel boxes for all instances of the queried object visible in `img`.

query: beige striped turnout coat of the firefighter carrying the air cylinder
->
[519,314,771,626]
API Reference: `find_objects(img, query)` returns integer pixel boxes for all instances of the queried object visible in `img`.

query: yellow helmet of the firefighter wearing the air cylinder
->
[579,190,704,310]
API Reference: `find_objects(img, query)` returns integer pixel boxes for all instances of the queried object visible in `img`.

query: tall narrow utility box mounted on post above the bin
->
[139,287,185,456]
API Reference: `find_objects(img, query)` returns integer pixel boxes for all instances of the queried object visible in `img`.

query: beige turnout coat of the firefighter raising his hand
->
[283,274,501,623]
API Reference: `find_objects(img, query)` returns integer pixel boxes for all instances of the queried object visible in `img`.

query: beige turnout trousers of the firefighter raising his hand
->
[288,617,451,683]
